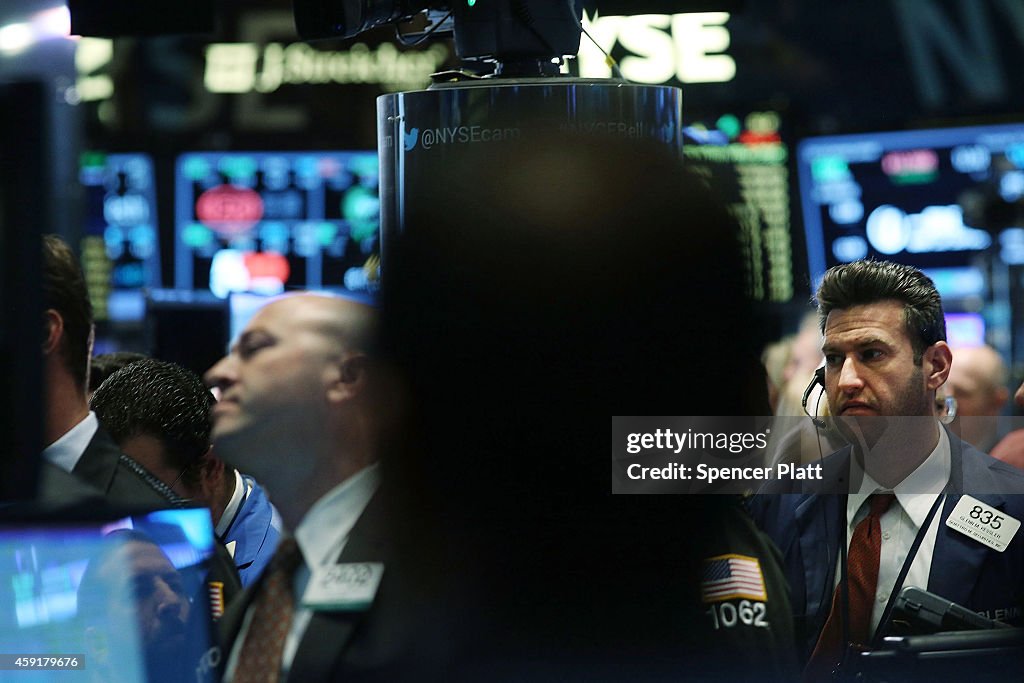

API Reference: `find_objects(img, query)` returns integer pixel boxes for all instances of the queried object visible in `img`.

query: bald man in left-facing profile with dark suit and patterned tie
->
[206,294,400,681]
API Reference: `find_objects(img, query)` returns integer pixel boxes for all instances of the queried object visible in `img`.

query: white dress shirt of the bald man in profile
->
[224,464,380,683]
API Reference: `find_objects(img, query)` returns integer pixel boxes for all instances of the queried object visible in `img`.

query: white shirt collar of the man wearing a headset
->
[846,425,951,528]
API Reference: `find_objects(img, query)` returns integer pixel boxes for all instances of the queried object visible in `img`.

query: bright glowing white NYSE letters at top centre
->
[579,12,736,84]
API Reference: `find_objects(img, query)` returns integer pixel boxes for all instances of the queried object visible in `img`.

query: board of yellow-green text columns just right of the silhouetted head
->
[683,112,798,303]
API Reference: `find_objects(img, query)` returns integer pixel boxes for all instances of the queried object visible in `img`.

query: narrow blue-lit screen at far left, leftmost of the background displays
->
[79,152,161,322]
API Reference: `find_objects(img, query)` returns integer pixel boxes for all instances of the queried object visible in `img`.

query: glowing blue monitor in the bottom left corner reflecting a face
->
[0,508,218,682]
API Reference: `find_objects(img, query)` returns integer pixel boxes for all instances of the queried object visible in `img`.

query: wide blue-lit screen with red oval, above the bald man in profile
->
[174,152,380,298]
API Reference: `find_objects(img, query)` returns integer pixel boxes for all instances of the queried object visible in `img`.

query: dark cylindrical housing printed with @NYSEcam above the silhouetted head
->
[377,78,682,270]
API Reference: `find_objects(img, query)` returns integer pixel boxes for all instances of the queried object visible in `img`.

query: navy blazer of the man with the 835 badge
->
[750,434,1024,659]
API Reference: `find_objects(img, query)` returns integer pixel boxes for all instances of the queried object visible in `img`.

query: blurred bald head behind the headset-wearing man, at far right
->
[945,346,1010,452]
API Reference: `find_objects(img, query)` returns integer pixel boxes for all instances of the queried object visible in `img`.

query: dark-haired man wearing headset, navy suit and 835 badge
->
[752,261,1024,680]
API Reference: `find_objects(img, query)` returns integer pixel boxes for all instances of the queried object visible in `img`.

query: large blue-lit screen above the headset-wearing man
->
[797,124,1024,299]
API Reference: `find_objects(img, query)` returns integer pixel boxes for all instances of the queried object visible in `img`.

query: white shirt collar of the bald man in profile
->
[295,464,380,568]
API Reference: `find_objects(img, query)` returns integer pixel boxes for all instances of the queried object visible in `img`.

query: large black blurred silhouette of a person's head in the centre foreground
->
[382,131,768,675]
